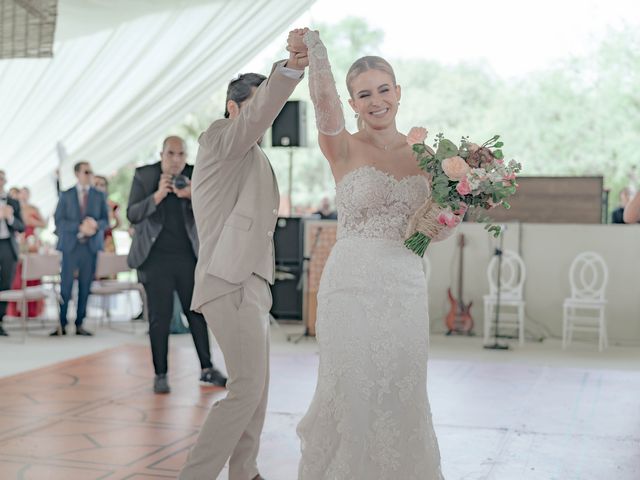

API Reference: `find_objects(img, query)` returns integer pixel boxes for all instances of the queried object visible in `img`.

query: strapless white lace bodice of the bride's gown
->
[336,166,430,241]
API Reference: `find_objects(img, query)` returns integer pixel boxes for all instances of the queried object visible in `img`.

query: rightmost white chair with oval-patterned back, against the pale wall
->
[562,252,609,351]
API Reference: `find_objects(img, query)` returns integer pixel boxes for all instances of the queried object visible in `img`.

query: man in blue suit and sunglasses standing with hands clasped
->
[51,161,109,336]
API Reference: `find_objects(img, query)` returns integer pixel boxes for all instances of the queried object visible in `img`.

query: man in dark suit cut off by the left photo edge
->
[0,170,24,337]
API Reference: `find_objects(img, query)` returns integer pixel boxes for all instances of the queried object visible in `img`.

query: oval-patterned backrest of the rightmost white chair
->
[569,252,609,300]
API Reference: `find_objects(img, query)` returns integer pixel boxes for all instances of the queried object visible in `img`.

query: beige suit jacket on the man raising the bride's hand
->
[191,61,300,311]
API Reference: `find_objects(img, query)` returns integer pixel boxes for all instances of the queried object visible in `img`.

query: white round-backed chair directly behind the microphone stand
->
[483,250,527,345]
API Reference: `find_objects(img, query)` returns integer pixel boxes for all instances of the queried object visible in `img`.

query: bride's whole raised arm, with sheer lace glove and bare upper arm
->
[303,30,349,163]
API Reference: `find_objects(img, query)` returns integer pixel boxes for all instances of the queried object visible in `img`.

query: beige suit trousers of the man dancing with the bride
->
[178,275,272,480]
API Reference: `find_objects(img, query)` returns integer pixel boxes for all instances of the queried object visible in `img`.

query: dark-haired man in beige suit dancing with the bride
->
[179,36,308,480]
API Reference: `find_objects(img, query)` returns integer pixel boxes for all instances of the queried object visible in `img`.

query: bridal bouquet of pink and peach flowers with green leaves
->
[404,127,522,257]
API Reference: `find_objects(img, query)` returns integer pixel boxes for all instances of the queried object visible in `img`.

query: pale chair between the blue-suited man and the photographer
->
[91,252,149,331]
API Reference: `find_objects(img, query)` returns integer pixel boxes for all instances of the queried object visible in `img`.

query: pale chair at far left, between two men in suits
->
[0,252,62,341]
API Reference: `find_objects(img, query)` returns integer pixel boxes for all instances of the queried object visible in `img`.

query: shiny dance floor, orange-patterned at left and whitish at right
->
[0,346,640,480]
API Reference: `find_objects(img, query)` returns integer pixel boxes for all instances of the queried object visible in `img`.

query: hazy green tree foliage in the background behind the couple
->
[106,18,640,220]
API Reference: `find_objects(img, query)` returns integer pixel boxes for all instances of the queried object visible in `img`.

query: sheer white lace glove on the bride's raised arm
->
[304,30,344,136]
